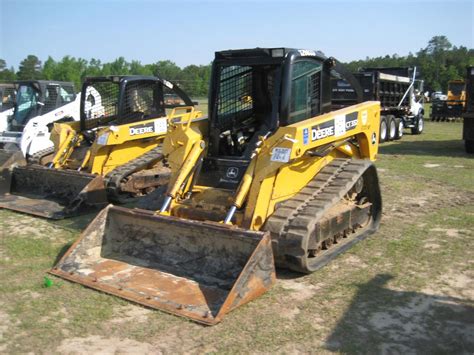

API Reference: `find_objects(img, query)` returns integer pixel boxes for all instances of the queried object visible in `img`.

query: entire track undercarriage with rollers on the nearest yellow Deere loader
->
[264,159,382,273]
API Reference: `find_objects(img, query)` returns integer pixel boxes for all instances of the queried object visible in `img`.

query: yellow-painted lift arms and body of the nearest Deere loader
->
[163,101,380,230]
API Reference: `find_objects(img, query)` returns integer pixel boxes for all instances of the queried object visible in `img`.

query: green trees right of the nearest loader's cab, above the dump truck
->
[347,36,474,92]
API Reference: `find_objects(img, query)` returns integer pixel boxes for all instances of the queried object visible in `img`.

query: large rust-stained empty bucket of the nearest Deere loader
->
[50,205,275,325]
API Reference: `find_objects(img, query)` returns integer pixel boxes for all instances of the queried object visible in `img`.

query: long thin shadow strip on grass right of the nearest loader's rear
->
[379,138,472,157]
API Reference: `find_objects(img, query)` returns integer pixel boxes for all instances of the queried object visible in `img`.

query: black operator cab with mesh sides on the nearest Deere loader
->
[197,48,344,190]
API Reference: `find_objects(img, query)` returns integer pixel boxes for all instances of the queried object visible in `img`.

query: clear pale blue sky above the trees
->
[0,0,474,69]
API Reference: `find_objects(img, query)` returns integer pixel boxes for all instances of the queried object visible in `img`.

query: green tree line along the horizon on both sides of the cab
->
[0,36,474,97]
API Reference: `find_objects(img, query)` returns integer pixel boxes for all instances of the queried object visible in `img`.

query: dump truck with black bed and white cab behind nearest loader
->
[332,67,424,143]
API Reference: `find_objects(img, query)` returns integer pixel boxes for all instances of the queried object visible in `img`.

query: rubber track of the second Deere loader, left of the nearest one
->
[104,145,163,202]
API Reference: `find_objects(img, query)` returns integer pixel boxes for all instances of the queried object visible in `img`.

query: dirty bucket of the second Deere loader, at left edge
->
[0,165,107,219]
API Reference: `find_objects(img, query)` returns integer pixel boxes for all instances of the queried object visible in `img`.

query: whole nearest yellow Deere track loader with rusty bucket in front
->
[51,48,382,324]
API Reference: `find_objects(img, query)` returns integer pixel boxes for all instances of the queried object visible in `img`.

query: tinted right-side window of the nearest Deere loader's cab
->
[288,60,321,124]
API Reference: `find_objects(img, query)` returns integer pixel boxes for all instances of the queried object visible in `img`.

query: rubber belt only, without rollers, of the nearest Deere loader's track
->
[265,159,372,273]
